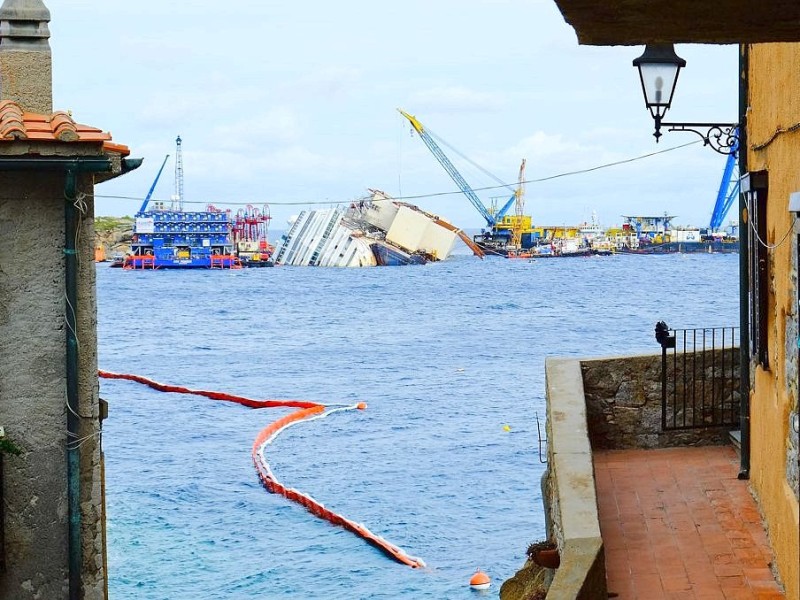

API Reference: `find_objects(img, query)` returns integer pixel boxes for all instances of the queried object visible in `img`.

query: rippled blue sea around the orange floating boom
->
[97,252,739,600]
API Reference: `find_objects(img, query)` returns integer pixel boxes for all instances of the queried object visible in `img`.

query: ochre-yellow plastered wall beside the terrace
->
[747,44,800,598]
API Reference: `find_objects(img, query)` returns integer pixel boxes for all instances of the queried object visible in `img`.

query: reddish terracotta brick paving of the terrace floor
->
[593,446,785,600]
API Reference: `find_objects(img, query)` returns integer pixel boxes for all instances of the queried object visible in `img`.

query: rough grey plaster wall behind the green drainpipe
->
[0,171,105,600]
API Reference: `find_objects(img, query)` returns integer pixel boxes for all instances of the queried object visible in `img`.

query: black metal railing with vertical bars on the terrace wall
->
[656,321,740,431]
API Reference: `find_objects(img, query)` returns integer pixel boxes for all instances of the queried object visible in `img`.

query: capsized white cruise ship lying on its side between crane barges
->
[273,189,483,267]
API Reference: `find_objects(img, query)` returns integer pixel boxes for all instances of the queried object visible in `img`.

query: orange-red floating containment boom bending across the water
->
[98,370,425,569]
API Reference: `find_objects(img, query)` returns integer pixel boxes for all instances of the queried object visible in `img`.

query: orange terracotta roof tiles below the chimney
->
[0,100,130,156]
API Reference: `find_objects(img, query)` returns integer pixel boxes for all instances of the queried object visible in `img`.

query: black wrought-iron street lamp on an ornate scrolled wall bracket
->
[633,44,738,154]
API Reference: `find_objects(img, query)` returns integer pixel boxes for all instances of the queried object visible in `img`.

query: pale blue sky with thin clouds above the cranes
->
[44,0,738,229]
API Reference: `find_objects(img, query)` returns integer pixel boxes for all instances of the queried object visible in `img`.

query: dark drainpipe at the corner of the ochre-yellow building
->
[739,44,750,479]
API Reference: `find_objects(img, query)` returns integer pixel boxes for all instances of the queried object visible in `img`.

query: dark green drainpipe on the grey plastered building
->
[64,169,83,600]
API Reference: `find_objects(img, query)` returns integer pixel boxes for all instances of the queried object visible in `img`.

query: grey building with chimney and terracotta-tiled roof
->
[0,0,141,600]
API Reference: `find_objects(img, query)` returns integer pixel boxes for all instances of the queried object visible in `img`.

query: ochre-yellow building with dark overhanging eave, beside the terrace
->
[544,0,800,598]
